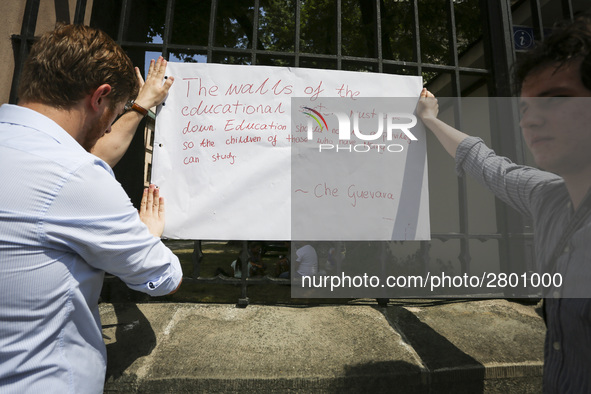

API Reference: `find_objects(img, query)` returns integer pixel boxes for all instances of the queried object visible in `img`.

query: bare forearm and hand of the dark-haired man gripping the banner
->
[417,88,469,158]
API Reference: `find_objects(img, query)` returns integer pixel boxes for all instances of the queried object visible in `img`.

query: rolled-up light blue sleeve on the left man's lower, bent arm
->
[39,160,182,296]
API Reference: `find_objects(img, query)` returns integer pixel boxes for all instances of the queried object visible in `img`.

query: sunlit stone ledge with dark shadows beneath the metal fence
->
[100,300,545,394]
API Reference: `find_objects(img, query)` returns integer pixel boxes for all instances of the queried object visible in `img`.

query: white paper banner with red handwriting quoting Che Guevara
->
[151,62,430,240]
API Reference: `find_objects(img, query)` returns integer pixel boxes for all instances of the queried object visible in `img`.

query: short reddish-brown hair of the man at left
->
[18,23,139,108]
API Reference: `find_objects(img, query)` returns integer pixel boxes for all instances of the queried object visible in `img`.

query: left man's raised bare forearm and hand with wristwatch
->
[92,56,174,168]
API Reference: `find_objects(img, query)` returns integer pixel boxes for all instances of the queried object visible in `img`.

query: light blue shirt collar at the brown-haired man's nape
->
[0,104,86,152]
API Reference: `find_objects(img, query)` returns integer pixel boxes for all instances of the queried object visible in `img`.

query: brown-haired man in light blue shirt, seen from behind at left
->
[0,25,182,394]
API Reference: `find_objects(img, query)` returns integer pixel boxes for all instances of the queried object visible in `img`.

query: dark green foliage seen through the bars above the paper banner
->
[104,0,482,69]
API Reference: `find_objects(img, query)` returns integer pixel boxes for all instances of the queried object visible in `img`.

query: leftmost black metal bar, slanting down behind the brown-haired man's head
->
[9,0,40,104]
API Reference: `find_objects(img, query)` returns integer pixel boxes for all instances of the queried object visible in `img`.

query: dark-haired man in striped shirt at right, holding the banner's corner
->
[417,13,591,393]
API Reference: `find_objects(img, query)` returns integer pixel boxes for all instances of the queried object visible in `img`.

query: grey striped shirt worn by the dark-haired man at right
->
[456,137,591,393]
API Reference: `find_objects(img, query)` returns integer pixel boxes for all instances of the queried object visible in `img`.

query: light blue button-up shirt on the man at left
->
[0,105,182,394]
